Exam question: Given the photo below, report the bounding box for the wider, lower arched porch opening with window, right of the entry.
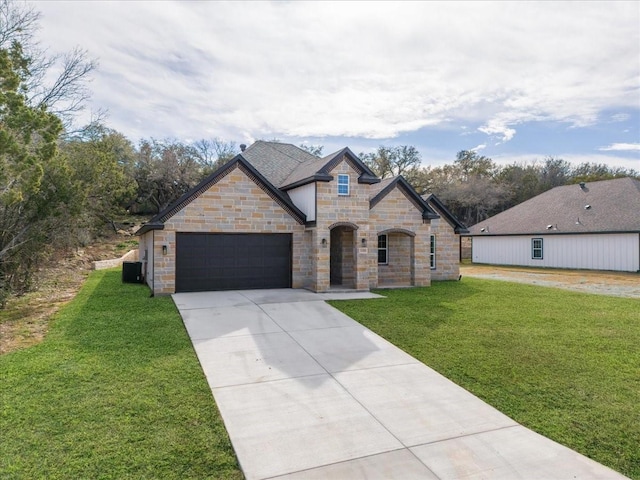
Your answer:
[378,228,416,287]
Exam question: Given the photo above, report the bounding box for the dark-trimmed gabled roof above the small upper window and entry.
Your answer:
[280,148,380,190]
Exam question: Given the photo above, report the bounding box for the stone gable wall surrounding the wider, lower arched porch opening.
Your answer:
[369,187,431,288]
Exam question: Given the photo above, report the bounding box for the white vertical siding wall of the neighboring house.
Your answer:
[472,233,640,272]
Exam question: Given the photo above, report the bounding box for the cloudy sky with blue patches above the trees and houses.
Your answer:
[30,0,640,171]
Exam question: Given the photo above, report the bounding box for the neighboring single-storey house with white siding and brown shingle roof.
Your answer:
[469,178,640,272]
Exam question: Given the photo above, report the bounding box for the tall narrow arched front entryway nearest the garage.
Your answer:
[329,223,358,288]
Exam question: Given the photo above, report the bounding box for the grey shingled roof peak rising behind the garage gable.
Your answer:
[242,140,319,187]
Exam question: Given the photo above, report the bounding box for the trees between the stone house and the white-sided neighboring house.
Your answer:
[360,146,640,226]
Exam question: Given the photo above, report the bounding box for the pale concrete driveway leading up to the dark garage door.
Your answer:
[173,289,625,480]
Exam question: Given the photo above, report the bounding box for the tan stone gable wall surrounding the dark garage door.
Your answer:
[153,164,311,294]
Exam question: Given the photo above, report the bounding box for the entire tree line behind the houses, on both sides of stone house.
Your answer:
[0,0,638,307]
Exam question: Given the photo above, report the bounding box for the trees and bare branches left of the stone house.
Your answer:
[0,0,242,307]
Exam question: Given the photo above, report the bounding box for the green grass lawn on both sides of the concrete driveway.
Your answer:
[0,271,640,480]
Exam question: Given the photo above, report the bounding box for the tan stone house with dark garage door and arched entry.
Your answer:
[137,141,466,294]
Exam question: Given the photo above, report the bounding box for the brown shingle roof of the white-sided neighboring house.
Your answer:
[469,177,640,236]
